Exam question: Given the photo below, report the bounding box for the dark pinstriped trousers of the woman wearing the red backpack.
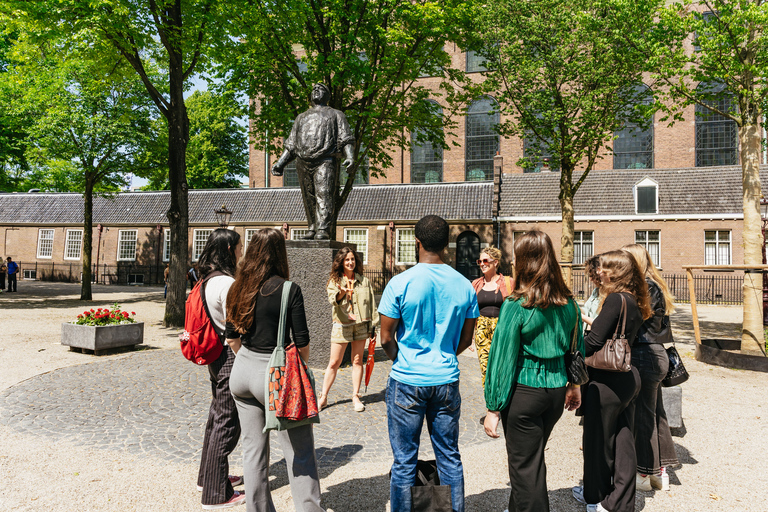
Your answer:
[197,347,240,505]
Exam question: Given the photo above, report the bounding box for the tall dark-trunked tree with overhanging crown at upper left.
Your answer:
[0,0,232,327]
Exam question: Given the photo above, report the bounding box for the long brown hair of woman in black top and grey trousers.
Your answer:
[227,228,289,334]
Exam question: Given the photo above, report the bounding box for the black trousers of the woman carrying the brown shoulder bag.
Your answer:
[581,366,640,512]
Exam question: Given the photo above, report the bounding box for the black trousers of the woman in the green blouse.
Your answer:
[501,384,565,512]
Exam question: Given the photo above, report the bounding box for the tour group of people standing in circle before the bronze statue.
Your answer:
[190,215,677,512]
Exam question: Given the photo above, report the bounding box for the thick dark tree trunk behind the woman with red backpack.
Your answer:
[164,56,189,327]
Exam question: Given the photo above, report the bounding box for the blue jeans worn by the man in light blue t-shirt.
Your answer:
[387,378,464,512]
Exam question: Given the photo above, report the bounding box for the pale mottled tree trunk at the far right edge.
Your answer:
[739,122,765,355]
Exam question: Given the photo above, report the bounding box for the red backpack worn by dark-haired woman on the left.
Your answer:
[179,272,225,365]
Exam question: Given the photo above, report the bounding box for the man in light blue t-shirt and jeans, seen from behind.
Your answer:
[379,215,479,512]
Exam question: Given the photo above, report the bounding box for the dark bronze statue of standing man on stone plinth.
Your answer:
[272,84,355,240]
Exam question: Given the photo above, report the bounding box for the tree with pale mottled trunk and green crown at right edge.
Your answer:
[640,0,768,354]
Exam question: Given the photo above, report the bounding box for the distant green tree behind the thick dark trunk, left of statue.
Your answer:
[136,91,248,190]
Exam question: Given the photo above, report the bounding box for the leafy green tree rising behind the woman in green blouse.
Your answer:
[477,0,650,278]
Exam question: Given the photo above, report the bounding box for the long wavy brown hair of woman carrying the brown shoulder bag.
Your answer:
[600,251,653,320]
